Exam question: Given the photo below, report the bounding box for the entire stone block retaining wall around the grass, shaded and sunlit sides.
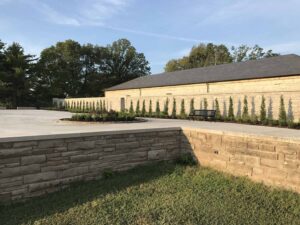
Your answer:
[0,128,300,202]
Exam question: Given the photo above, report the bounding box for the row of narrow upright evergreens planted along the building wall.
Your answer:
[128,96,300,129]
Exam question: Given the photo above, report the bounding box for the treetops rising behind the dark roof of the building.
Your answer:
[165,43,279,72]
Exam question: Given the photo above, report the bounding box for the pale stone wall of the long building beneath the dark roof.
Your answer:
[105,76,300,121]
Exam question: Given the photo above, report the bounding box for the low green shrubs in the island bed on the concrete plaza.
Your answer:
[71,111,136,122]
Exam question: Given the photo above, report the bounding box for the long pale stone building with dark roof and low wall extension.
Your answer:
[66,54,300,120]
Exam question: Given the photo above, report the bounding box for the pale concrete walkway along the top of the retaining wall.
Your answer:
[0,110,300,140]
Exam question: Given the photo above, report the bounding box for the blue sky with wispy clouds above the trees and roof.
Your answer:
[0,0,300,73]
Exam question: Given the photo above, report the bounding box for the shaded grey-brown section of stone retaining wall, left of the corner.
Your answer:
[0,129,181,202]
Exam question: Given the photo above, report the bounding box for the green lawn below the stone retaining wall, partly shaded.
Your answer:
[0,163,300,225]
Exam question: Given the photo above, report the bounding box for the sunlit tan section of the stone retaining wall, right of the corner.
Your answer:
[181,129,300,193]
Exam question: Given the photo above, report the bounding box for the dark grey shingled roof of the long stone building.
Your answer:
[106,54,300,91]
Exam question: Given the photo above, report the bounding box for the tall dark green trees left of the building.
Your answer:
[0,39,150,108]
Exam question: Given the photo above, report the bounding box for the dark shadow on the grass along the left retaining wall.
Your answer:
[0,162,176,225]
